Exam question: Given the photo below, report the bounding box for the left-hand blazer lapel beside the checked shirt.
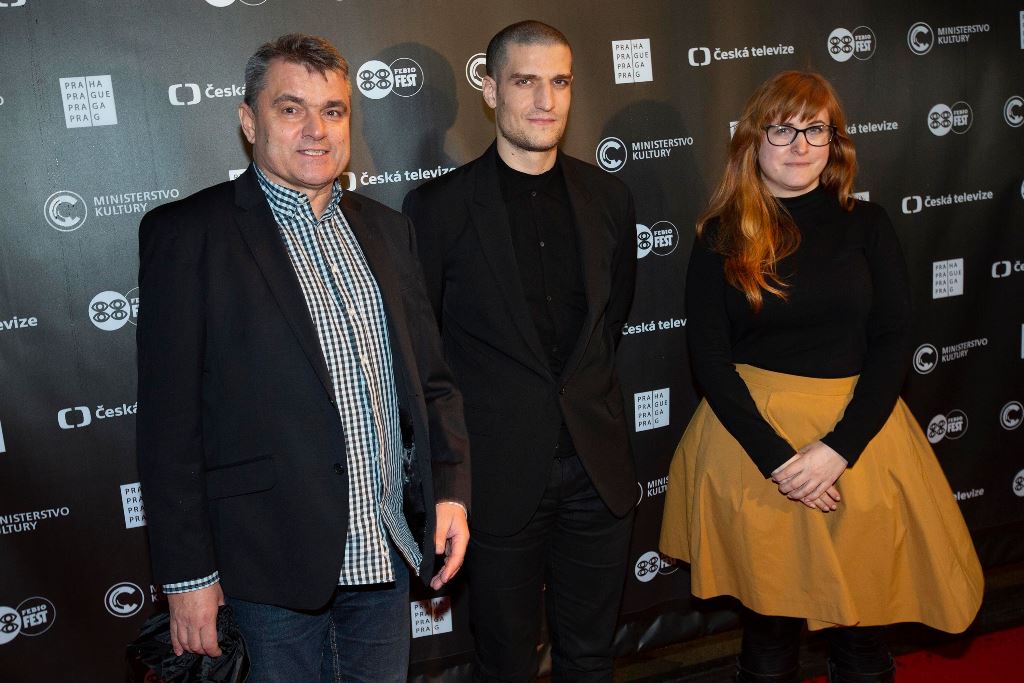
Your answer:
[234,165,334,398]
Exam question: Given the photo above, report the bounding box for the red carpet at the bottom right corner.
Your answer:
[808,627,1024,683]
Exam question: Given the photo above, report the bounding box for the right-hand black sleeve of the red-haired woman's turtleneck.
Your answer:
[821,206,910,467]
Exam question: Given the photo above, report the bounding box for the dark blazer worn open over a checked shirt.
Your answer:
[137,168,469,608]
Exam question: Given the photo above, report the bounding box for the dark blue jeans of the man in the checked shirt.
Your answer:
[227,549,412,683]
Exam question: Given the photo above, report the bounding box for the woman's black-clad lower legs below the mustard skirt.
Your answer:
[739,609,892,676]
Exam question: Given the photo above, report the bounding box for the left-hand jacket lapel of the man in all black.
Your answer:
[470,144,551,375]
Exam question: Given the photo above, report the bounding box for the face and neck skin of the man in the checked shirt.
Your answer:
[239,59,351,217]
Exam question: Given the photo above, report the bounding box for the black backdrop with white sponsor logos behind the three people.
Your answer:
[0,0,1024,681]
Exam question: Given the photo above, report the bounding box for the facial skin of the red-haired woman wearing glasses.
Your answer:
[758,109,830,197]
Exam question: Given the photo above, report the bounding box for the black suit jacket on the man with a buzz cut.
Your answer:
[403,144,637,535]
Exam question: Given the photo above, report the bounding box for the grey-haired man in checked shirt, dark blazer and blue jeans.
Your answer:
[138,35,469,683]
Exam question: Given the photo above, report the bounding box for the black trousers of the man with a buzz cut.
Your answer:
[466,450,633,681]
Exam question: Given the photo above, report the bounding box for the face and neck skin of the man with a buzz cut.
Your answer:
[483,43,572,175]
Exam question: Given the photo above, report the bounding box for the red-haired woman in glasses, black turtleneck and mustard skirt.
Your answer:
[660,72,983,683]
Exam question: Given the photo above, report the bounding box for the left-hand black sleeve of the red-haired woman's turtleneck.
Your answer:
[686,229,797,478]
